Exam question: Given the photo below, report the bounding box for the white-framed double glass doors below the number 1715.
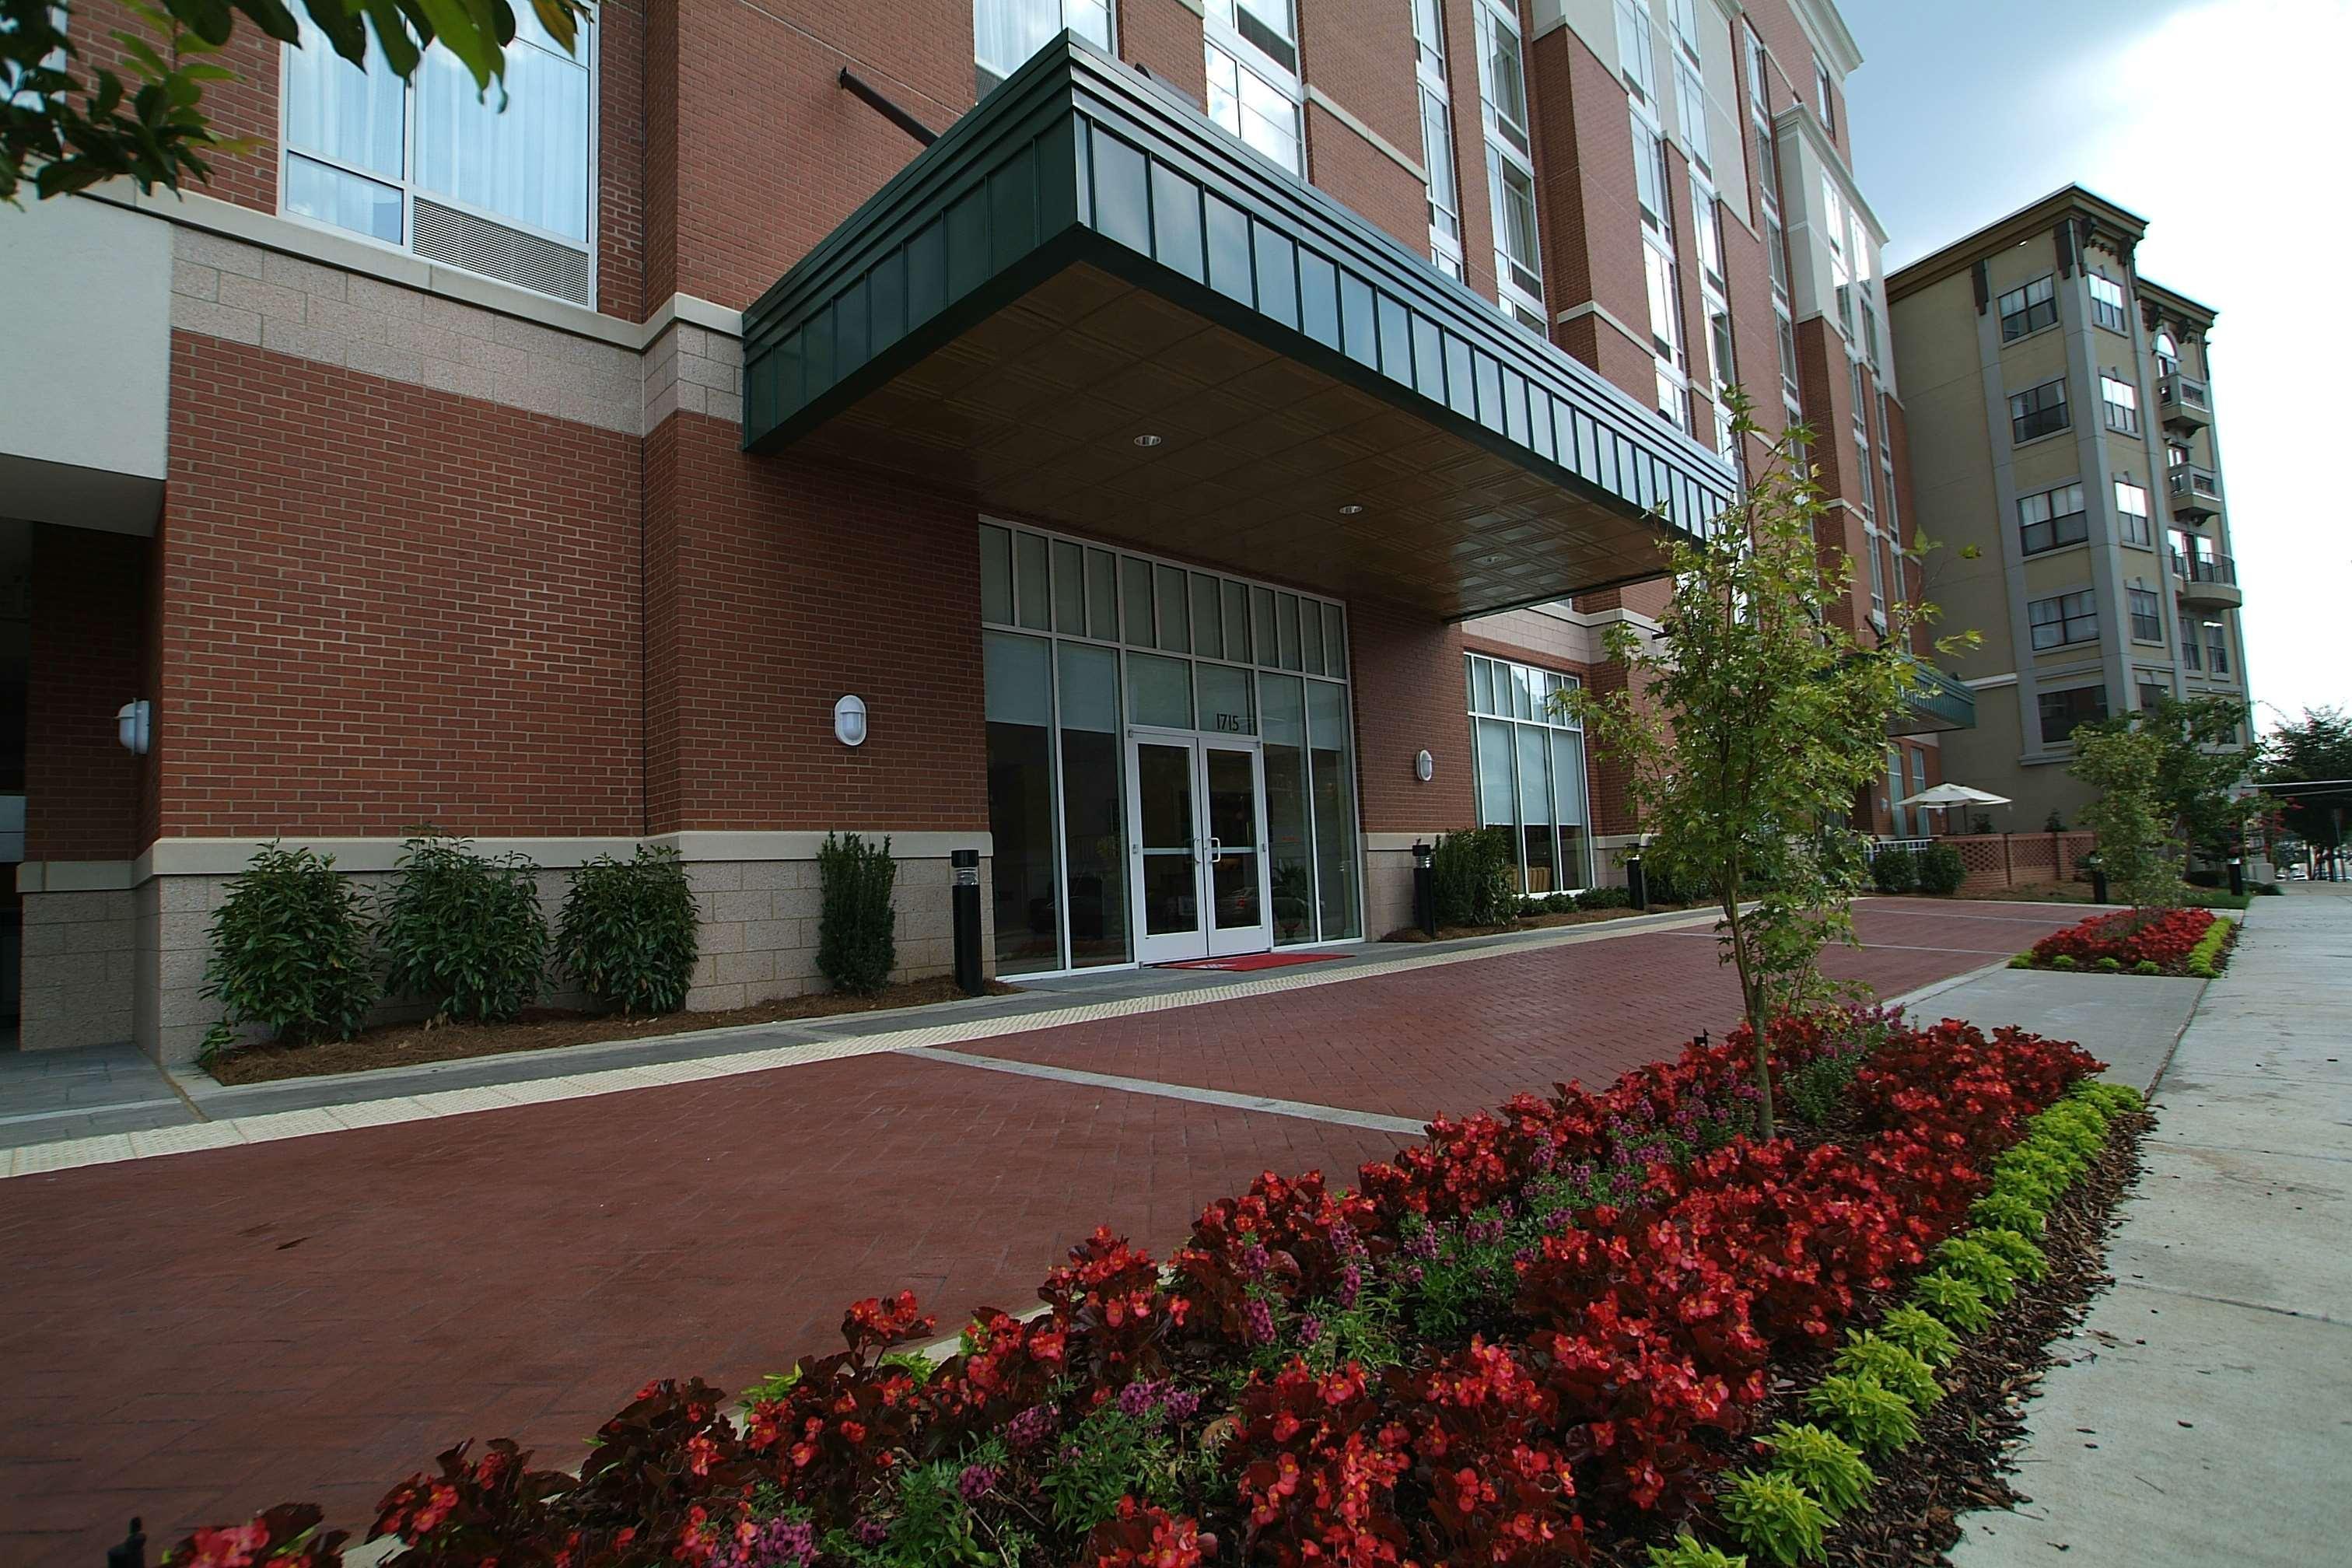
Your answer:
[1126,733,1275,964]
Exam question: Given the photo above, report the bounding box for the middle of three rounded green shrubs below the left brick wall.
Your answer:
[376,828,548,1023]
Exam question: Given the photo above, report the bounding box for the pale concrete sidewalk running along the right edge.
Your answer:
[1929,884,2352,1568]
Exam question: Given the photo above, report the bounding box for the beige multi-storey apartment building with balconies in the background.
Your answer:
[1886,186,2246,830]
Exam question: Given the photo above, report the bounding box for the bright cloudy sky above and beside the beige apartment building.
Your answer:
[1842,0,2352,729]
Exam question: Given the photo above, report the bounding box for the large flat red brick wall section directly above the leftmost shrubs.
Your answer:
[156,331,642,837]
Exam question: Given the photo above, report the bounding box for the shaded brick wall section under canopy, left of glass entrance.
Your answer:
[647,414,988,832]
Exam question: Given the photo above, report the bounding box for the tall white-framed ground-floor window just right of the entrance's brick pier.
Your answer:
[1465,653,1592,896]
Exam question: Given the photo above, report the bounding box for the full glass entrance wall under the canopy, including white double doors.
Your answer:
[981,522,1364,975]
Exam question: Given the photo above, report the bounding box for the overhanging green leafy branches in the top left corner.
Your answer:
[0,0,593,205]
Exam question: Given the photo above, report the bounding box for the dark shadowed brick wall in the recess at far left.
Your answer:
[23,524,153,860]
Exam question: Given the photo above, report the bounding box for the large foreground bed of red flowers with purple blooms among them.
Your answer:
[174,1013,2098,1568]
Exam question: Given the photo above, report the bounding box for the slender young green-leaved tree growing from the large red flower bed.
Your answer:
[1559,393,1966,1138]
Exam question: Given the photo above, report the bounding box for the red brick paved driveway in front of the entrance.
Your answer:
[0,901,2060,1566]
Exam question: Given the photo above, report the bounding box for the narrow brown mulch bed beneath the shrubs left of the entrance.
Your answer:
[207,975,1018,1083]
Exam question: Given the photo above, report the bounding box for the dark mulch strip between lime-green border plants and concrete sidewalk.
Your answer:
[1757,1115,2154,1568]
